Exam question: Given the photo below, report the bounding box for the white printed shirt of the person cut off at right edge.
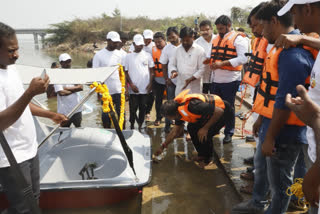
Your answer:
[307,53,320,162]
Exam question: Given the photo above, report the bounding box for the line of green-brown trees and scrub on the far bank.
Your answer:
[46,7,250,45]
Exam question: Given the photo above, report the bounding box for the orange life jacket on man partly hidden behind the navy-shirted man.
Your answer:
[243,37,268,87]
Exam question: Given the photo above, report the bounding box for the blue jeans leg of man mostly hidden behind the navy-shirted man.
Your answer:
[252,135,269,208]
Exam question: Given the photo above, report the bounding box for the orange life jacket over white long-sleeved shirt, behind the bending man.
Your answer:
[211,31,242,71]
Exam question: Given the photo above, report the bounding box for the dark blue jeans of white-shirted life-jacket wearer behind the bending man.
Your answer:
[211,81,240,136]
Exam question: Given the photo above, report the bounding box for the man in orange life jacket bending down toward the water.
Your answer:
[155,89,234,167]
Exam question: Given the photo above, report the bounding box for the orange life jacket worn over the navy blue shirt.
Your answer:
[252,47,316,126]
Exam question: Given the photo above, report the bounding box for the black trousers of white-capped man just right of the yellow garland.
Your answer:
[129,94,149,126]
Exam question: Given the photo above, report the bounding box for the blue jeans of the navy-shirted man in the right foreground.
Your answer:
[266,141,303,214]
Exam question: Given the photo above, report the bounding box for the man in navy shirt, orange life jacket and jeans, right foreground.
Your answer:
[248,0,314,214]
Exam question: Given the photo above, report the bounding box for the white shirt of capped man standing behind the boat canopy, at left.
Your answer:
[54,85,82,115]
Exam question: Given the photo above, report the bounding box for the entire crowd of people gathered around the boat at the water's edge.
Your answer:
[0,0,320,214]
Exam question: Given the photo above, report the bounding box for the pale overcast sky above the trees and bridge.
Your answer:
[0,0,261,28]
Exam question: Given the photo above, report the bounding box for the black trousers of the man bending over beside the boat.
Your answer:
[188,101,234,162]
